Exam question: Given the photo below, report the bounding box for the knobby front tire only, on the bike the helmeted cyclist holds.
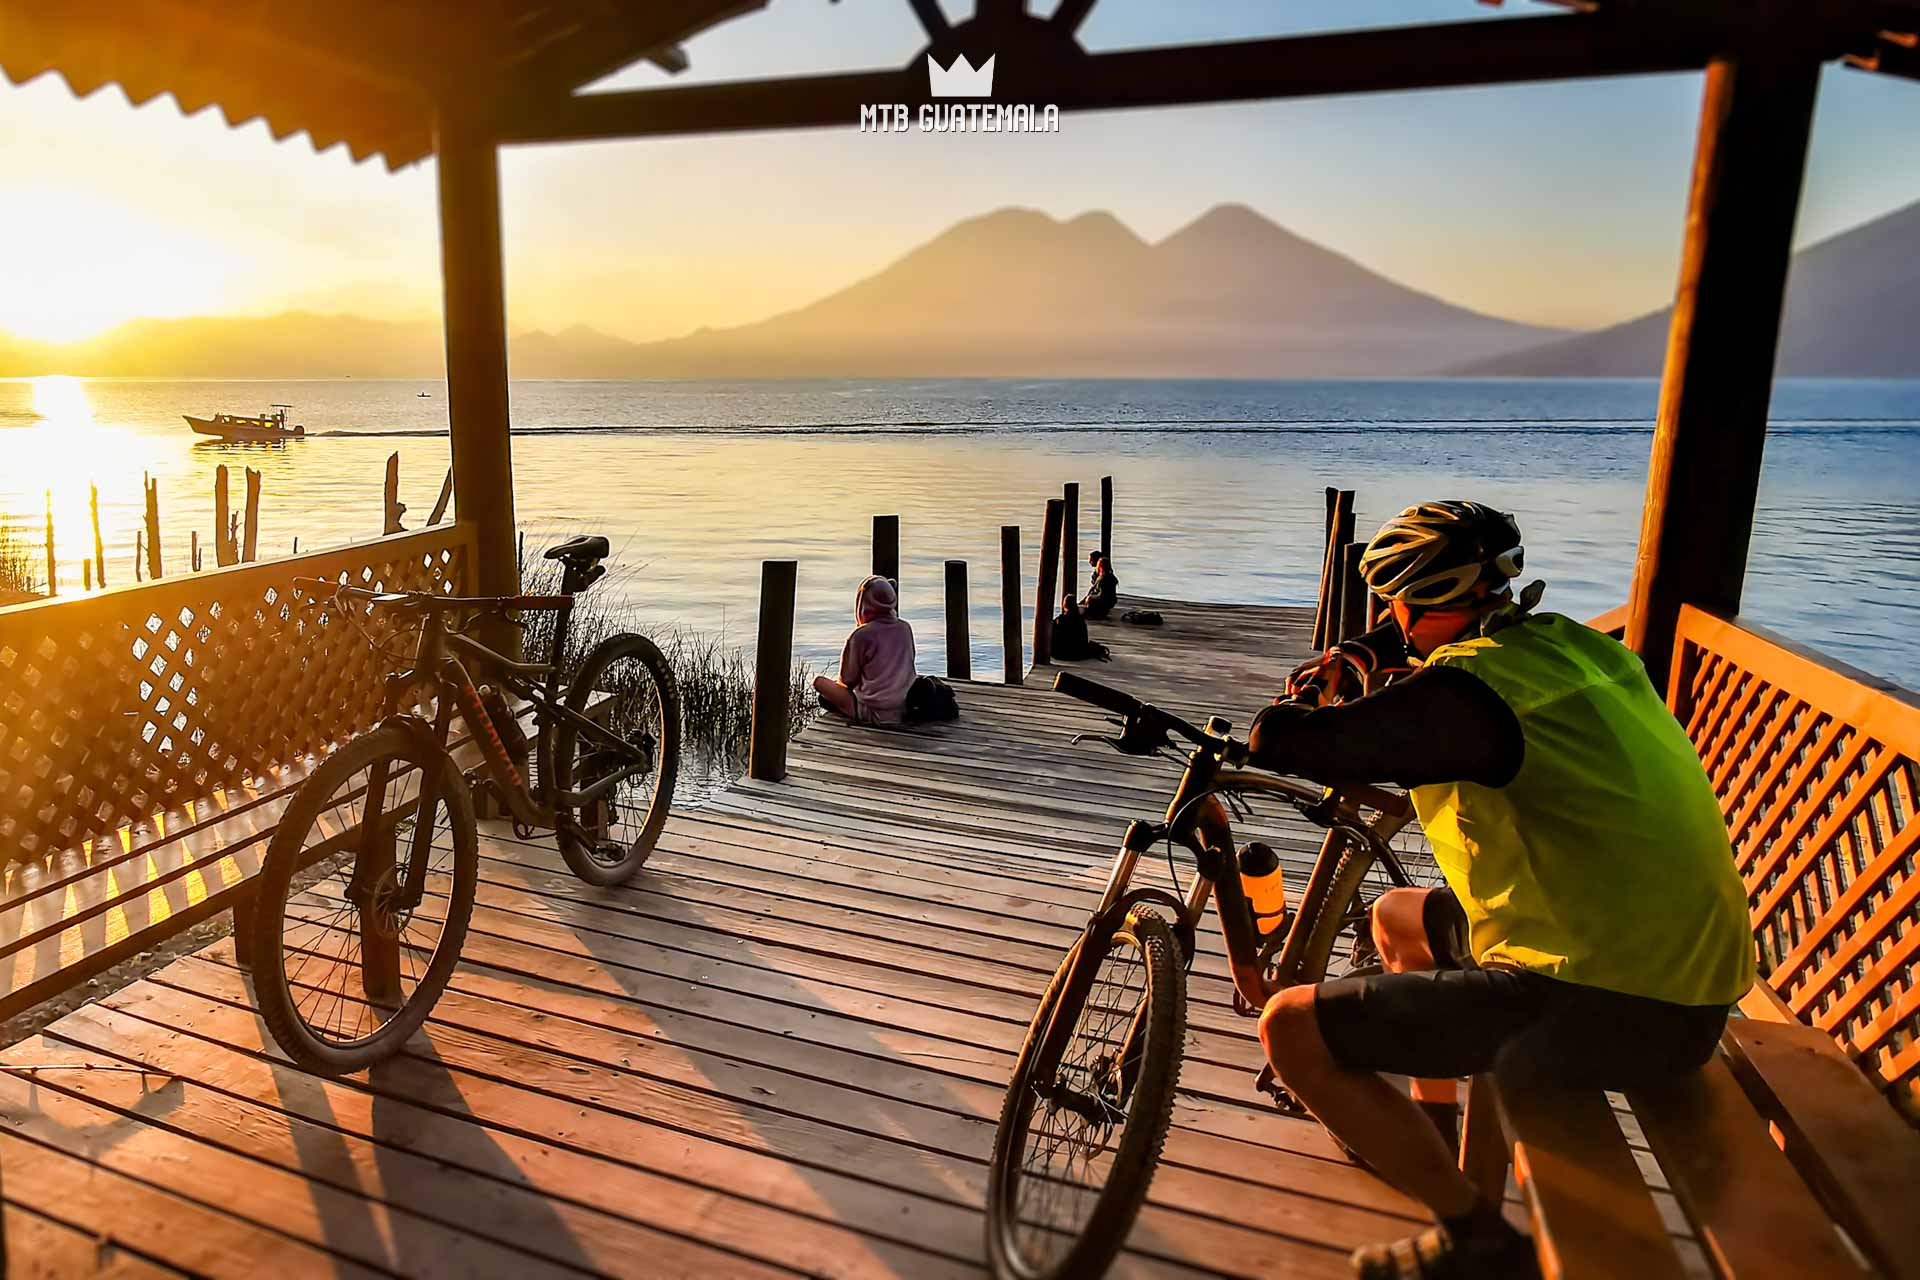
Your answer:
[987,912,1187,1280]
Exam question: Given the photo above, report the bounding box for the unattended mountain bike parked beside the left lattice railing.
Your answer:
[248,537,680,1075]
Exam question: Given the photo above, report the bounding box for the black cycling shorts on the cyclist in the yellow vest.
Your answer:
[1313,889,1726,1088]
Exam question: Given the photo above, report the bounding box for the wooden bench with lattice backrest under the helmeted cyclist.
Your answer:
[1461,608,1920,1280]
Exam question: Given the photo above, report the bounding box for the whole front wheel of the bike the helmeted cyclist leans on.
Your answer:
[987,912,1187,1280]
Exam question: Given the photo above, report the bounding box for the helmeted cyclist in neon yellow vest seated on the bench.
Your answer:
[1250,503,1755,1280]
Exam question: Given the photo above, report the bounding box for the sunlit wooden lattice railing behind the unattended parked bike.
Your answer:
[0,524,472,860]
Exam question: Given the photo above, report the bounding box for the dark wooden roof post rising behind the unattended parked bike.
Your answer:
[434,106,520,644]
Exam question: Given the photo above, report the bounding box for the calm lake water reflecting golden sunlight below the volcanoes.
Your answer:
[0,378,1920,687]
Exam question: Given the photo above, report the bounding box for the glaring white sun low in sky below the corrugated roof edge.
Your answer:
[0,184,232,342]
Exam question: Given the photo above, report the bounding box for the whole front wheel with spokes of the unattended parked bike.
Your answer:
[252,725,480,1075]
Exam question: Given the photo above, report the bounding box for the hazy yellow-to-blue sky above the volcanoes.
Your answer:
[0,0,1920,338]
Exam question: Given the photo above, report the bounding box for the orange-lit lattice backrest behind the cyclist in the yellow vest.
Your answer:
[1668,608,1920,1111]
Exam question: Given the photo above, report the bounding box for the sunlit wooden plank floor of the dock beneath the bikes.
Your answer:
[0,601,1443,1278]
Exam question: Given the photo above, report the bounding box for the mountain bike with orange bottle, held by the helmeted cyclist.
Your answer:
[987,674,1415,1280]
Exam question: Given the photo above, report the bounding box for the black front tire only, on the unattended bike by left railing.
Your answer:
[250,725,480,1077]
